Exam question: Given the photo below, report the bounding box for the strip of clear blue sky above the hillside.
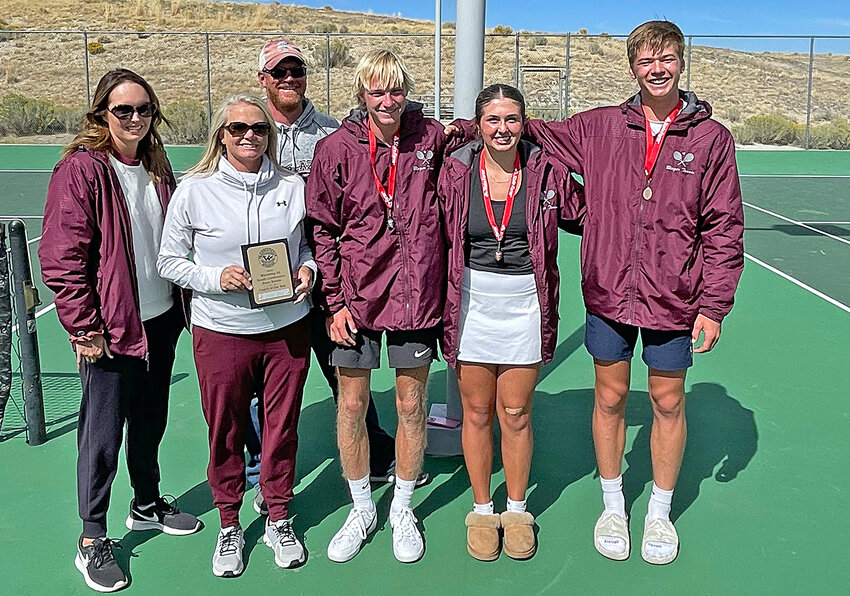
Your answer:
[260,0,850,35]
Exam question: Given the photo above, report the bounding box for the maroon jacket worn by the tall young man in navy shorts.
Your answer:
[526,92,744,330]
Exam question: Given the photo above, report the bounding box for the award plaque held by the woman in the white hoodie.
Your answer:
[242,238,296,308]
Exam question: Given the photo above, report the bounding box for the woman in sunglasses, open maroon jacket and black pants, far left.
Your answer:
[38,69,201,592]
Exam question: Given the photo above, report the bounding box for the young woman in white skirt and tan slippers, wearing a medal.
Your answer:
[438,85,581,561]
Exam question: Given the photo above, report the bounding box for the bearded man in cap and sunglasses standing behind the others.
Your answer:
[246,39,412,514]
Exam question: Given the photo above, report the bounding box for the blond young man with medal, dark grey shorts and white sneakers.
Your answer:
[307,50,460,563]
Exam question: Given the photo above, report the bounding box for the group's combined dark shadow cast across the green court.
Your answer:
[151,340,758,560]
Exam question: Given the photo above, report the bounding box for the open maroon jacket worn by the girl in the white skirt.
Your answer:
[438,140,584,366]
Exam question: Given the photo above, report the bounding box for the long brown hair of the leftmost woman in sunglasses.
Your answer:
[62,68,171,181]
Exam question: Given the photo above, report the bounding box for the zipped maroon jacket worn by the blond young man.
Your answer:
[306,103,460,330]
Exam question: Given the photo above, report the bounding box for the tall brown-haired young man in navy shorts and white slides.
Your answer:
[526,21,743,564]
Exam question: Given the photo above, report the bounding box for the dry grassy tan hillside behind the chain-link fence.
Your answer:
[0,0,850,146]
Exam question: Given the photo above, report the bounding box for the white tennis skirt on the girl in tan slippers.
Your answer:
[457,267,542,364]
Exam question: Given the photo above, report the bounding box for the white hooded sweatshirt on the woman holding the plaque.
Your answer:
[157,156,316,335]
